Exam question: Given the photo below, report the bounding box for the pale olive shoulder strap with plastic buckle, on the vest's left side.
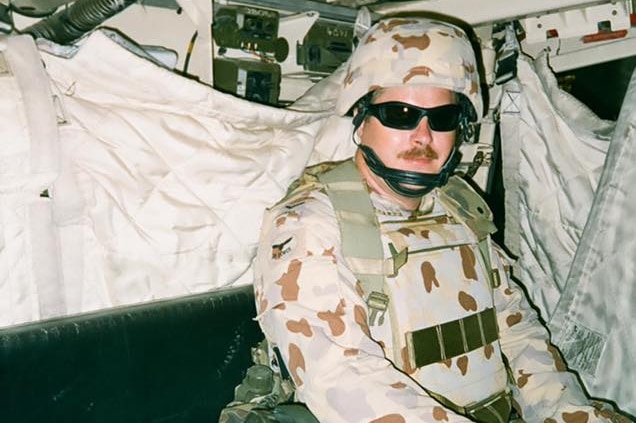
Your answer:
[318,160,395,326]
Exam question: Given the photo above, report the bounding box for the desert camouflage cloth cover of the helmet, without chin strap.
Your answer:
[336,17,483,117]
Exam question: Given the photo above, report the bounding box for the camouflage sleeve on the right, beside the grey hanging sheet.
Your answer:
[493,248,629,423]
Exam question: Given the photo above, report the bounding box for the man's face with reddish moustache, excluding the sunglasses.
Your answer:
[358,86,456,173]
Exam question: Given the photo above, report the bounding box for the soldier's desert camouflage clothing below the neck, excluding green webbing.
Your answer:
[255,161,628,423]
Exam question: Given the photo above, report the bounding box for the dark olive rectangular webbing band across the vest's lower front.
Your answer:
[406,308,499,368]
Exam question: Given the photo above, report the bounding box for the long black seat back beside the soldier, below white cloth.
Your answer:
[0,286,262,423]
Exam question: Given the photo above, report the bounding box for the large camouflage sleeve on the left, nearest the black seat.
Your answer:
[254,192,468,423]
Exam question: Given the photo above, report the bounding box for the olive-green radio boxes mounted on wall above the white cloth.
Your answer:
[212,0,356,106]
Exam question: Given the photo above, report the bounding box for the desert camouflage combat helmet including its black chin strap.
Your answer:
[335,16,483,197]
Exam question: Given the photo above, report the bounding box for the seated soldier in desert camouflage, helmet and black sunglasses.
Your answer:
[254,16,627,423]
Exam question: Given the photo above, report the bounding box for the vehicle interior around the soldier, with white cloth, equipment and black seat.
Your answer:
[0,0,636,423]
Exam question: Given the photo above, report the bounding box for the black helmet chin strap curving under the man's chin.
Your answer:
[358,144,462,198]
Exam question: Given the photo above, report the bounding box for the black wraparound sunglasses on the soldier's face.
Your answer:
[367,101,462,132]
